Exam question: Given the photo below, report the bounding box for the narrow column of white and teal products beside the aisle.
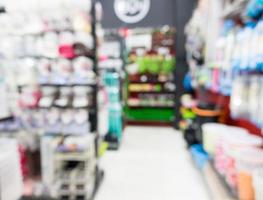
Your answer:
[99,31,125,149]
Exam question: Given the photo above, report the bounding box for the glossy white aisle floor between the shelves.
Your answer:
[95,127,209,200]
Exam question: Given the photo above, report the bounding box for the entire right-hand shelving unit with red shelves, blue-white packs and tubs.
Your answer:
[185,0,263,200]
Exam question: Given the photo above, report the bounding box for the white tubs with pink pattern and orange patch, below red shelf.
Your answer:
[202,123,263,199]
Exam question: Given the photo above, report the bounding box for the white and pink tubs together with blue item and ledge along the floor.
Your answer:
[190,123,263,200]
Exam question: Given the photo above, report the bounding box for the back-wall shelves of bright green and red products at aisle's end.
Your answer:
[125,27,176,122]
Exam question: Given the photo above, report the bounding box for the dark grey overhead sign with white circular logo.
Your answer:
[100,0,176,28]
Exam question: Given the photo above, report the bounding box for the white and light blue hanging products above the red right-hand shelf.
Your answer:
[186,1,262,96]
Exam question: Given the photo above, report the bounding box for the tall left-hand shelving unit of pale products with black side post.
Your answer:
[1,0,104,200]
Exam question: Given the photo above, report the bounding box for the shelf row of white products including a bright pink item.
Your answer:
[0,30,94,59]
